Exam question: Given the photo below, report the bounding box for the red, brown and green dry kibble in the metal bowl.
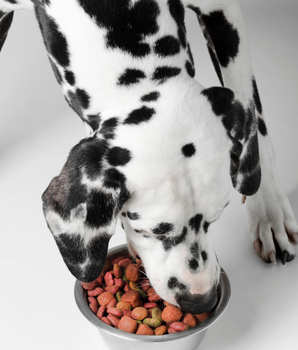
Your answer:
[82,255,212,335]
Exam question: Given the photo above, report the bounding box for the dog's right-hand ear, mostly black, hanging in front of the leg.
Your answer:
[202,87,261,196]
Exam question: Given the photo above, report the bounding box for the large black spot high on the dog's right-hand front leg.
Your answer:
[201,11,240,68]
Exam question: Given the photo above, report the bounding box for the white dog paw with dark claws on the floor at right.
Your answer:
[242,186,298,265]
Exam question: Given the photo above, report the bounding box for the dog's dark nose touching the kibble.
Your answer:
[175,288,218,314]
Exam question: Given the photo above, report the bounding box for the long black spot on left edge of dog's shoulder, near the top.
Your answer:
[35,3,69,68]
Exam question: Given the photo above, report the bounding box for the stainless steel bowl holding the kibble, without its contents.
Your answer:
[74,244,231,350]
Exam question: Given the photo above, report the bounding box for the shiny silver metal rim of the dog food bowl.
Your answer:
[74,244,231,343]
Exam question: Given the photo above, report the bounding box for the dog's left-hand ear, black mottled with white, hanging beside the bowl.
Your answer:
[42,136,129,282]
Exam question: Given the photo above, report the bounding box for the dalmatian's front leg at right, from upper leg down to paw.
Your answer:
[185,0,298,264]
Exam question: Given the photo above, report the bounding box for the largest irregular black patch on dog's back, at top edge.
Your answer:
[78,0,159,57]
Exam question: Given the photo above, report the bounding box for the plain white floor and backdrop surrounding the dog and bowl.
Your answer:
[0,0,298,350]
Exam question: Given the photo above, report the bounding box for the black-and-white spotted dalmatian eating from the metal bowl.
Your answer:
[0,0,298,313]
